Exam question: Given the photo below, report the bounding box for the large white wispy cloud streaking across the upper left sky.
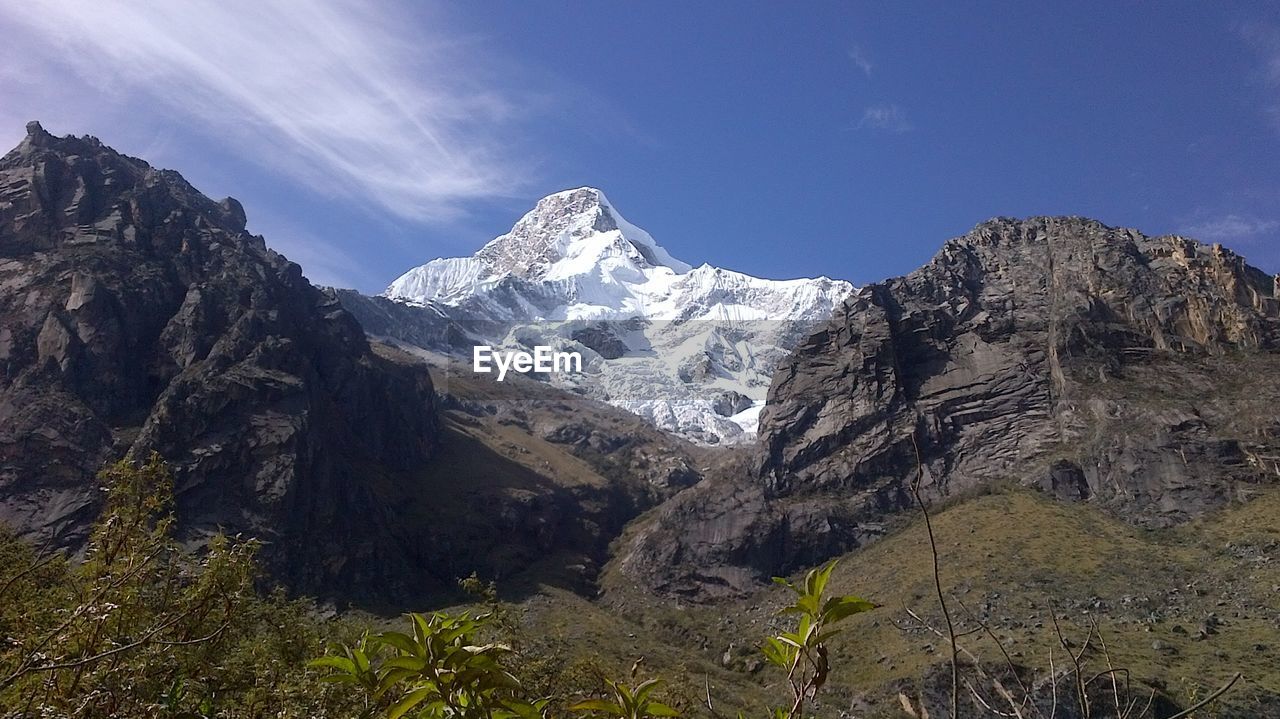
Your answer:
[0,0,529,221]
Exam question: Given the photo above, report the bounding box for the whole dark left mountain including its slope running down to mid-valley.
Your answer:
[0,124,732,598]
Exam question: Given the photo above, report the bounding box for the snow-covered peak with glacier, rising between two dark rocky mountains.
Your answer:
[384,187,854,444]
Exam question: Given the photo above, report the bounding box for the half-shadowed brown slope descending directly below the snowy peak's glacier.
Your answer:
[380,349,716,596]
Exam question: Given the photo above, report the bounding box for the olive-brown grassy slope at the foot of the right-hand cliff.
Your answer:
[509,489,1280,715]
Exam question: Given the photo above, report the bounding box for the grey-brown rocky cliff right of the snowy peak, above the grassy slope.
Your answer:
[606,217,1280,596]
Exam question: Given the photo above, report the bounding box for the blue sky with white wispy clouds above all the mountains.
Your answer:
[0,0,1280,292]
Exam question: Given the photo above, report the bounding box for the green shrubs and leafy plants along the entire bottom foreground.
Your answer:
[0,457,1267,719]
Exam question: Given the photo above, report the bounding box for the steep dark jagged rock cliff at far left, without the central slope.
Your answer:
[0,124,436,594]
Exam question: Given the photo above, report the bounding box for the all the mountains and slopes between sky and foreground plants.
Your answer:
[0,123,1280,718]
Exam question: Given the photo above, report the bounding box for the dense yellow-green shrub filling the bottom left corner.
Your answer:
[0,455,351,718]
